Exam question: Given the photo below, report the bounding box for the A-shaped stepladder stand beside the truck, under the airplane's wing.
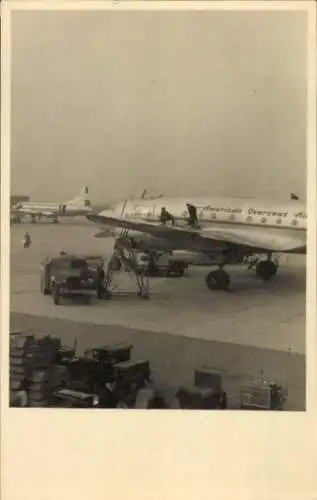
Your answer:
[104,228,149,299]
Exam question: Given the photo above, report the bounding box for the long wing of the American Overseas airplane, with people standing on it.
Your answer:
[86,214,306,252]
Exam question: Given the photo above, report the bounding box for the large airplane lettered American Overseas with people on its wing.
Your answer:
[86,193,307,290]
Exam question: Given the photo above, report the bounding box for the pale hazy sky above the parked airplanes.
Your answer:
[12,11,306,201]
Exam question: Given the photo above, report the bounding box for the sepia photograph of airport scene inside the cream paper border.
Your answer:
[9,2,308,412]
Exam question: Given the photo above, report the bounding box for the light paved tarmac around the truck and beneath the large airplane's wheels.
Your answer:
[10,221,306,410]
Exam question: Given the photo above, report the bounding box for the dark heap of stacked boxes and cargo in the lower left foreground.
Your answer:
[10,332,155,408]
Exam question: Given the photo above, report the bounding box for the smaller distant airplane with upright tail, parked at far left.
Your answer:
[11,186,92,223]
